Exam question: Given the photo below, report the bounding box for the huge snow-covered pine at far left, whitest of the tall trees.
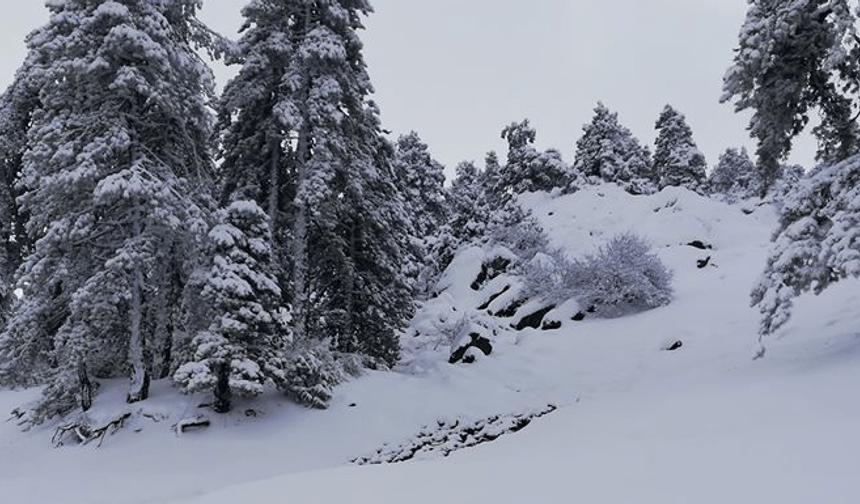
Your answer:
[0,0,217,422]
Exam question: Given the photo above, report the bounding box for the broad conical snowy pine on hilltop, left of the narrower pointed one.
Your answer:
[573,102,656,194]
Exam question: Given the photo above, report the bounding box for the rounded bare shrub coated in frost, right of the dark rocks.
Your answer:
[566,233,672,317]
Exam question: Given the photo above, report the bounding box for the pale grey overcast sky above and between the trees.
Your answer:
[0,0,814,178]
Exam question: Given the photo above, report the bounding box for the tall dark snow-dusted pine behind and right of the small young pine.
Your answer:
[221,0,412,364]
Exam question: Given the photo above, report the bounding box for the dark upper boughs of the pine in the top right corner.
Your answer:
[721,0,860,196]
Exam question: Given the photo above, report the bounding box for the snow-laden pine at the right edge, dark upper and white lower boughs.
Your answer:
[723,0,860,338]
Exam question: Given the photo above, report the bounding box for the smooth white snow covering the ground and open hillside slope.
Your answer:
[0,185,860,504]
